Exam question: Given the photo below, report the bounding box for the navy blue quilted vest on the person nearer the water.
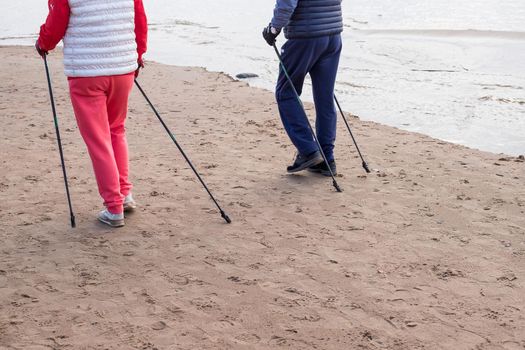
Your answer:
[284,0,343,39]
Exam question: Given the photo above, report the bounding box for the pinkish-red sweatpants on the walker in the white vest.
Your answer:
[68,73,134,214]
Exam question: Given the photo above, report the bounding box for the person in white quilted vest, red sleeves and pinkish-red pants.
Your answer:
[35,0,148,227]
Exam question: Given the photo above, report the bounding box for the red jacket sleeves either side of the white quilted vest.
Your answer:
[38,0,148,62]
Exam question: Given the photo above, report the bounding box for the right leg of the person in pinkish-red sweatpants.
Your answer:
[107,74,134,196]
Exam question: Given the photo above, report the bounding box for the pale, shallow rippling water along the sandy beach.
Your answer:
[0,0,525,155]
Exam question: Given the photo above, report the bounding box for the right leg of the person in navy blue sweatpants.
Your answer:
[310,35,342,161]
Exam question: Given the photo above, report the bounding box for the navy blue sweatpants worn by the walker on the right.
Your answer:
[275,34,342,161]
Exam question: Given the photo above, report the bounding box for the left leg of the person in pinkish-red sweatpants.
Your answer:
[69,77,124,214]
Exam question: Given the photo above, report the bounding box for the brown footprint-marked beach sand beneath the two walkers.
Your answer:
[0,47,525,350]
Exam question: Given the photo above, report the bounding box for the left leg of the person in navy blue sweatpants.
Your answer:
[275,39,326,156]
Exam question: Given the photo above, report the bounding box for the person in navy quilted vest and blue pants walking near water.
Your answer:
[263,0,343,176]
